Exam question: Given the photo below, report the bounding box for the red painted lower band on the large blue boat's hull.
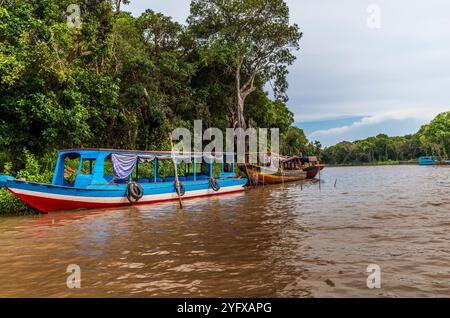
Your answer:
[7,188,245,213]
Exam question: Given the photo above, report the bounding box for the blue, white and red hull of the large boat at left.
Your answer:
[6,179,247,213]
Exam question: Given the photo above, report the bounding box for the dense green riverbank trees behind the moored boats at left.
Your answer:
[0,0,312,171]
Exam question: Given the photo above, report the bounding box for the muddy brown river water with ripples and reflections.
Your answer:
[0,166,450,297]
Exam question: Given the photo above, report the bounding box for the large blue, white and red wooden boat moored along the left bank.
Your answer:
[4,149,247,213]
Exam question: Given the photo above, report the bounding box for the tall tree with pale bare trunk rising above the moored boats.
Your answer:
[188,0,302,128]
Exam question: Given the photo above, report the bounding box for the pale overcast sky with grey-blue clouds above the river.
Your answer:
[124,0,450,145]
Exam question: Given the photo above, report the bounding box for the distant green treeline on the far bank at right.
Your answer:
[320,112,450,165]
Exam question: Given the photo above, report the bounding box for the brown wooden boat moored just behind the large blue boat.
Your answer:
[239,157,307,186]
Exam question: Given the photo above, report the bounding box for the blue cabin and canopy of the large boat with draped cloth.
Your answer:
[52,148,239,187]
